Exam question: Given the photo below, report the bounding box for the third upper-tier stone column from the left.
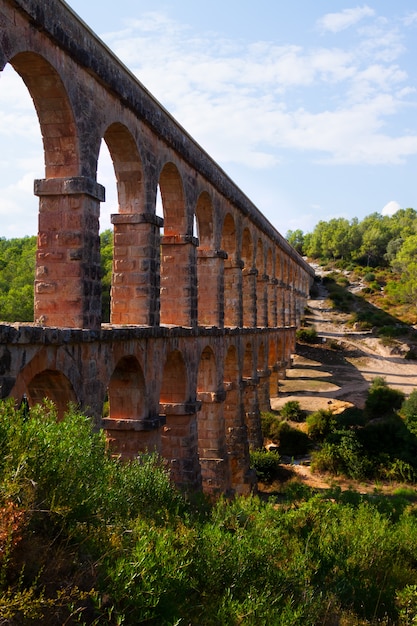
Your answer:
[161,235,198,327]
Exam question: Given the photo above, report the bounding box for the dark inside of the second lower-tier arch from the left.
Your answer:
[107,355,146,420]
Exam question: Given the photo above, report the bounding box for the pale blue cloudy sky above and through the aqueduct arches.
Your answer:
[0,0,417,237]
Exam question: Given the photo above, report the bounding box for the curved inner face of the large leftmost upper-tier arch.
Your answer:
[10,52,79,178]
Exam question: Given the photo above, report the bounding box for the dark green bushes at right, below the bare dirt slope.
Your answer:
[262,376,417,484]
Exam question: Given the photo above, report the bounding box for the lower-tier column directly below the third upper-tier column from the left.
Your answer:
[160,402,202,489]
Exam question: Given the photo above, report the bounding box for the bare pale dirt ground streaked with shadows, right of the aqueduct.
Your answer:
[266,280,417,493]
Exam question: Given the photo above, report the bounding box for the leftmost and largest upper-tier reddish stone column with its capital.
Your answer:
[34,176,104,328]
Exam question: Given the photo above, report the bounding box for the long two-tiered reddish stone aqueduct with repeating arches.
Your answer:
[0,0,313,493]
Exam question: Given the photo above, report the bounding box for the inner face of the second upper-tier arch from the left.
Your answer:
[103,122,145,214]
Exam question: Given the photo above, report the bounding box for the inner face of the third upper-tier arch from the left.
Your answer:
[159,163,188,235]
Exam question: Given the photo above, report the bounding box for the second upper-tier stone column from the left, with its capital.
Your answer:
[110,213,163,326]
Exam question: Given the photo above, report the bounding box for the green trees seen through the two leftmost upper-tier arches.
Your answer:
[0,230,113,322]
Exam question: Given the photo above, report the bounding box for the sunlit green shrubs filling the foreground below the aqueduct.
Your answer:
[0,401,417,626]
